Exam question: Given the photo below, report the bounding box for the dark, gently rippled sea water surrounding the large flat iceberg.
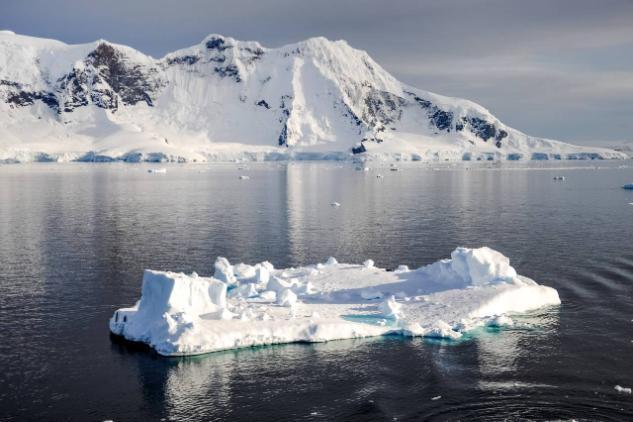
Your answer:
[0,162,633,421]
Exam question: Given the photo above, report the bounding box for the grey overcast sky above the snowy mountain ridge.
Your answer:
[0,0,633,144]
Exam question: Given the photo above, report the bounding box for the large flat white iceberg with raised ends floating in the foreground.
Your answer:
[110,247,560,356]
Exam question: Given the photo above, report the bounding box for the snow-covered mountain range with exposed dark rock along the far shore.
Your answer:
[0,31,626,162]
